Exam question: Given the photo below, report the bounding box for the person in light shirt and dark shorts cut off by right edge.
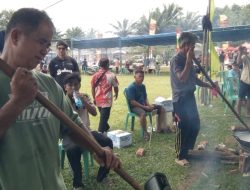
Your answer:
[237,46,250,117]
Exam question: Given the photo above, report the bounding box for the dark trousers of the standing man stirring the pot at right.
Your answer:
[173,93,200,160]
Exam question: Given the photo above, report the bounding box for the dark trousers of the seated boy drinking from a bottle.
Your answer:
[66,131,113,187]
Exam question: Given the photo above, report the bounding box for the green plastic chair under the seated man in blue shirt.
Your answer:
[123,88,153,138]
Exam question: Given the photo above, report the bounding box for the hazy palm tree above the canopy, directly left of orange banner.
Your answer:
[110,18,135,37]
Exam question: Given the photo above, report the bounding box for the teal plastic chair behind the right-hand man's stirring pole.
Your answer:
[224,77,239,114]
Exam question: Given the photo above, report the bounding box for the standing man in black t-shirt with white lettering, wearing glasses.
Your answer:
[49,40,80,88]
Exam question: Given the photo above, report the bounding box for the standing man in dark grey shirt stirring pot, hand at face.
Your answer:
[170,32,212,166]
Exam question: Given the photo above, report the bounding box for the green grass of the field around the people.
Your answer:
[63,72,250,190]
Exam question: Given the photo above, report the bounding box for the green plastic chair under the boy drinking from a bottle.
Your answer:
[58,142,94,178]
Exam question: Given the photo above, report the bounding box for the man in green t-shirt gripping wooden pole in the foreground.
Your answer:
[0,8,120,190]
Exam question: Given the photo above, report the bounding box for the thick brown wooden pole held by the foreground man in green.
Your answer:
[0,59,142,190]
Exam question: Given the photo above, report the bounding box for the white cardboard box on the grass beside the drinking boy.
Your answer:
[107,130,132,148]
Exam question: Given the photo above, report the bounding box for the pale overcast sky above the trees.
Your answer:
[0,0,250,36]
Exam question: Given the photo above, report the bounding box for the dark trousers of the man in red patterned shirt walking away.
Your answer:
[98,107,111,133]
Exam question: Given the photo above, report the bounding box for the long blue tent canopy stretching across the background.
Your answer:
[71,25,250,49]
